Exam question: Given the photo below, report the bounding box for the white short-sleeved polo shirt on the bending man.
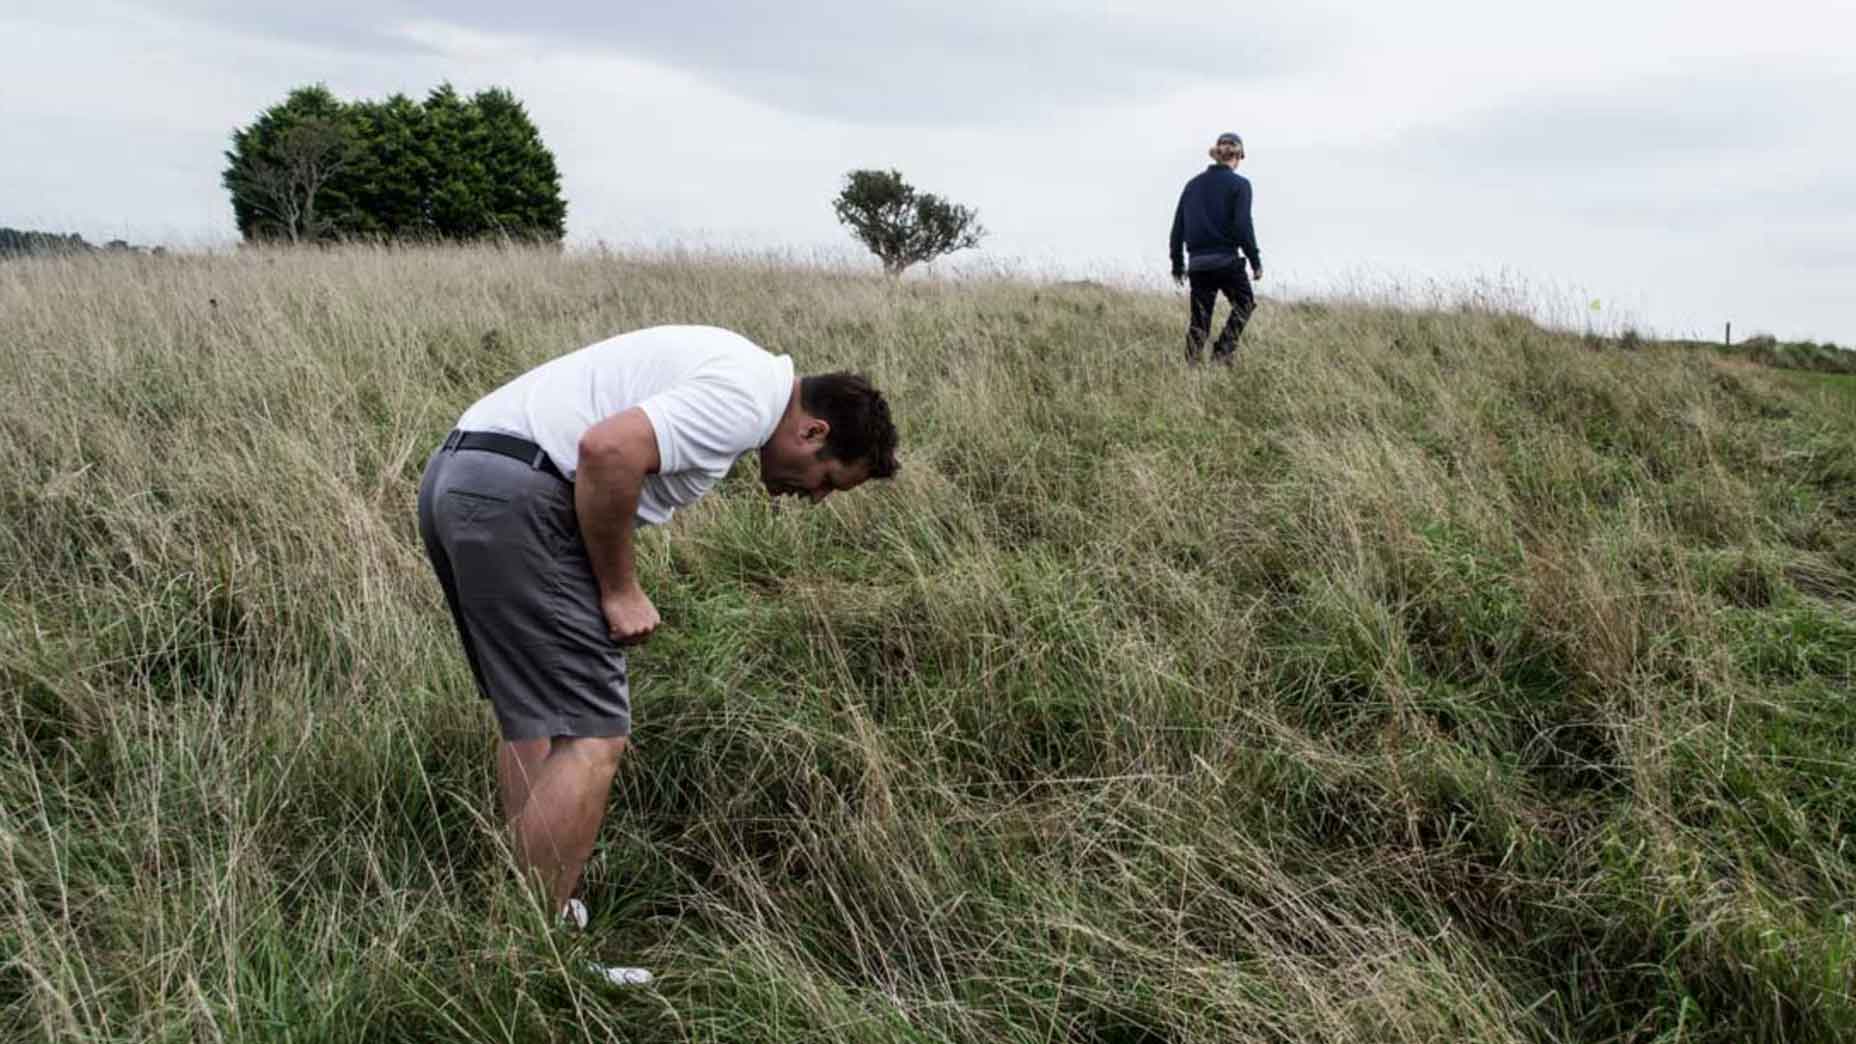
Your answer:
[458,327,793,526]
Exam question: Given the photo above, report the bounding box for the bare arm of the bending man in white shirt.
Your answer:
[574,407,661,645]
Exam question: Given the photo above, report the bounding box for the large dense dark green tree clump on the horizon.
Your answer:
[221,84,568,243]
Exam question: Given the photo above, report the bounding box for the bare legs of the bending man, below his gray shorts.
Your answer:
[497,736,629,910]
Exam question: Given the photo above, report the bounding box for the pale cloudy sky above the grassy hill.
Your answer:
[0,0,1856,346]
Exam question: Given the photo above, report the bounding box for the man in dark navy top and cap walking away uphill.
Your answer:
[1167,130,1264,362]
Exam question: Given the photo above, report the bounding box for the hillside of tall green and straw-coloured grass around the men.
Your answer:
[0,249,1856,1044]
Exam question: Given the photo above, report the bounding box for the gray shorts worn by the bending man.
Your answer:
[419,438,631,739]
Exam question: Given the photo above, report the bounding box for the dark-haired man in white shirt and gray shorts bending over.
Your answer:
[419,327,896,981]
